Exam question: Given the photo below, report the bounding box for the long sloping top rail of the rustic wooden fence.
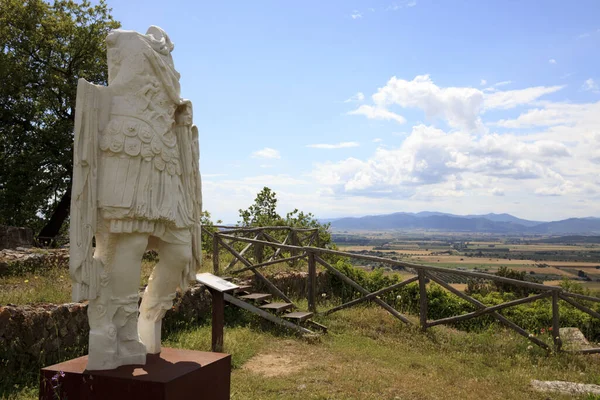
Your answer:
[221,234,562,292]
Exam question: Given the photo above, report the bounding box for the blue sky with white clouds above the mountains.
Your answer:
[107,0,600,223]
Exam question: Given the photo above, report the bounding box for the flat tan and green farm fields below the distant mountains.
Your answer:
[334,232,600,291]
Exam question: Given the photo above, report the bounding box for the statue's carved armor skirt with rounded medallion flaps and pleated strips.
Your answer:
[98,112,194,233]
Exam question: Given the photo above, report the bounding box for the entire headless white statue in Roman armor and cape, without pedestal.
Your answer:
[70,26,202,370]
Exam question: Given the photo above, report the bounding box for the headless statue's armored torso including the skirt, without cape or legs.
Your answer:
[98,31,193,232]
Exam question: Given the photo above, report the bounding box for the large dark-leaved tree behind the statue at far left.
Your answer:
[0,0,120,237]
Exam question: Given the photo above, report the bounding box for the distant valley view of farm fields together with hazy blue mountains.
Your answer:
[325,212,600,291]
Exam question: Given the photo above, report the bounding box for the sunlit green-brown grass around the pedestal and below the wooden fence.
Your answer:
[8,307,600,400]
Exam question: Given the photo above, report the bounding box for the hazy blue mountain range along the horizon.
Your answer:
[321,211,600,235]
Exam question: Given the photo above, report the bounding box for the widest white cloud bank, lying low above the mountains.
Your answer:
[313,125,571,197]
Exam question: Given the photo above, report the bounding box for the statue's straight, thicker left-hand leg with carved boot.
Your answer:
[87,232,148,370]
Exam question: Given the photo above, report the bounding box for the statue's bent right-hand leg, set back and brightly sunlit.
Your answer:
[138,240,192,354]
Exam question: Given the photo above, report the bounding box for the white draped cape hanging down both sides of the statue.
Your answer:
[70,31,202,301]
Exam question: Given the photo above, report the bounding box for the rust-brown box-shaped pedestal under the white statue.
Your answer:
[40,348,231,400]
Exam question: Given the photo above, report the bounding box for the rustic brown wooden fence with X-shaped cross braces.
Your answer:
[205,227,600,354]
